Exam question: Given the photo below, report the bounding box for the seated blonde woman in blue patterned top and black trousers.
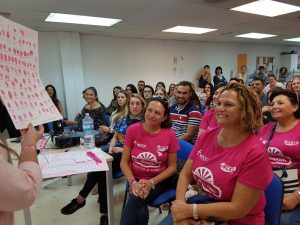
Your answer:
[61,94,146,225]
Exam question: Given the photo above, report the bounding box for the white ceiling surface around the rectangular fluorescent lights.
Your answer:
[0,0,300,45]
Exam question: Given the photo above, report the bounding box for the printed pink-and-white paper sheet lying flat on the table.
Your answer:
[38,149,108,178]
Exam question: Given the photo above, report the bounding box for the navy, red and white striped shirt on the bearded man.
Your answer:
[170,102,202,144]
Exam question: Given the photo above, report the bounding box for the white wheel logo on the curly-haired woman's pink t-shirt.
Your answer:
[193,167,222,198]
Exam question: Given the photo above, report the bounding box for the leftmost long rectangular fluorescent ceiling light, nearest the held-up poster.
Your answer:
[45,13,121,27]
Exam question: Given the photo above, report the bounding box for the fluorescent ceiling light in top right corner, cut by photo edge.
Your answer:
[230,0,300,17]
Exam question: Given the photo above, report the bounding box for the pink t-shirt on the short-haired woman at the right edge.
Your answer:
[257,120,300,171]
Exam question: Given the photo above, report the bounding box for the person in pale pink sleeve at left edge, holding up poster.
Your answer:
[0,124,44,225]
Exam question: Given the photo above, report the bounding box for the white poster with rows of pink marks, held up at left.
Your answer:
[0,16,62,129]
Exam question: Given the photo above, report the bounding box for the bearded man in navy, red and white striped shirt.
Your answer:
[170,81,202,144]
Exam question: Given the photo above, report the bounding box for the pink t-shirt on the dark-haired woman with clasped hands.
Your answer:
[125,123,179,179]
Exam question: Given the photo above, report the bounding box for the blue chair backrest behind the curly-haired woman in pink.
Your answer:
[264,174,283,225]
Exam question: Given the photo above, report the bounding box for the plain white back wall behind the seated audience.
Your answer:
[39,32,299,117]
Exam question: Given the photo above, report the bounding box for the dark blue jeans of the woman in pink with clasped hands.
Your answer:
[120,180,170,225]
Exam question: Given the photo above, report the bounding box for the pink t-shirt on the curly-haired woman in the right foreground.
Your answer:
[189,128,272,225]
